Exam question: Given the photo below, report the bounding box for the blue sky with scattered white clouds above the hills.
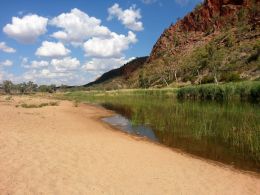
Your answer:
[0,0,201,85]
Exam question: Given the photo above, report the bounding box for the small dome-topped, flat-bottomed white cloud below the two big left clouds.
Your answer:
[35,41,70,57]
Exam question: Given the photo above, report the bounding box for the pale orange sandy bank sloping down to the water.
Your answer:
[0,97,260,195]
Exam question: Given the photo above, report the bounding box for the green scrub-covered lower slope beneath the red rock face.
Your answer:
[134,29,260,88]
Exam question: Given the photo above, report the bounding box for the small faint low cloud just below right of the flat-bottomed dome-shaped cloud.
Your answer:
[51,57,80,72]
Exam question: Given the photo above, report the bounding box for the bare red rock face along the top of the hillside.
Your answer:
[148,0,260,62]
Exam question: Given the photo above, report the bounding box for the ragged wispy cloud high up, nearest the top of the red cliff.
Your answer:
[108,3,143,31]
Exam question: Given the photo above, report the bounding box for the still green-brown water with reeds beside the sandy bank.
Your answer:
[99,96,260,172]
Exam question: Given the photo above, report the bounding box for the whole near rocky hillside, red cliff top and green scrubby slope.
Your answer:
[85,0,260,88]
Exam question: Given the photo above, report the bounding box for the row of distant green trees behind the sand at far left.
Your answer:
[0,80,57,94]
